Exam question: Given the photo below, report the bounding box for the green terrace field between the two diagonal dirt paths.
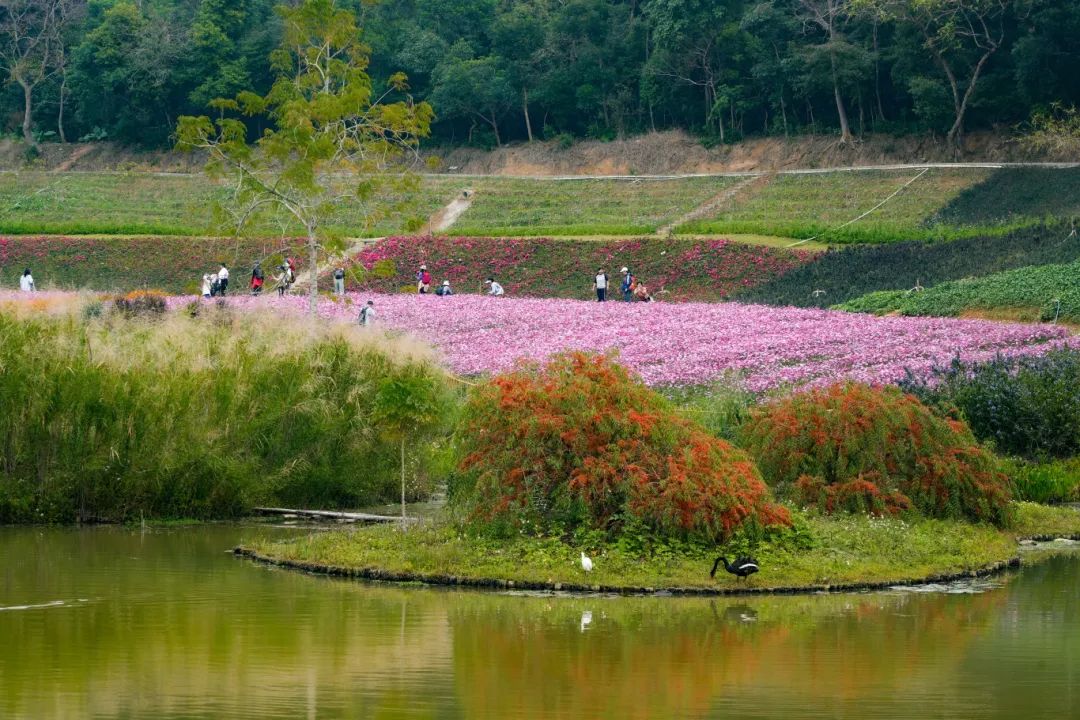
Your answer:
[453,177,741,235]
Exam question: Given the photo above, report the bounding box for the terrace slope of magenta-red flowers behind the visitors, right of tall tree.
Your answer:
[350,235,814,301]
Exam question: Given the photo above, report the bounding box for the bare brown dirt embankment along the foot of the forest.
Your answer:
[0,131,1062,176]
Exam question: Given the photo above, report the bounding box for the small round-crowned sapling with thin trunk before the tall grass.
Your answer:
[374,363,449,518]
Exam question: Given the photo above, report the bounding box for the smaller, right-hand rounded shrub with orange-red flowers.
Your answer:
[742,383,1011,525]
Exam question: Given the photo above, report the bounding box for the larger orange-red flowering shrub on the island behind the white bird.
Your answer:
[451,353,791,540]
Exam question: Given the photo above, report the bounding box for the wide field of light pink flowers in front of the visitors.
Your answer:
[171,294,1080,391]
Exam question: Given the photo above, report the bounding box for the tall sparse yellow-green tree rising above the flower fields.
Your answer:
[177,0,433,316]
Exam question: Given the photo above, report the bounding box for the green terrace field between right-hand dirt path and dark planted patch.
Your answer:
[679,167,993,242]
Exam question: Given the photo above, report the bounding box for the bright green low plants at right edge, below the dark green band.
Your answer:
[837,261,1080,323]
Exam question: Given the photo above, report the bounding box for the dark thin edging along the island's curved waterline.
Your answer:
[232,547,1021,597]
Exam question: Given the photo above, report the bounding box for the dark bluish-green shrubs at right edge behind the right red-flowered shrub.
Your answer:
[902,349,1080,459]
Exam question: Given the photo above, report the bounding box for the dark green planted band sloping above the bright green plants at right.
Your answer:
[735,221,1080,308]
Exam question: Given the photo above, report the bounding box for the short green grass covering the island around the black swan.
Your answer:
[240,503,1080,589]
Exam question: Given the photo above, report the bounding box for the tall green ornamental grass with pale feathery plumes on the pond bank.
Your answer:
[0,300,442,522]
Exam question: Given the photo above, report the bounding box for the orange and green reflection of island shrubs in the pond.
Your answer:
[449,590,1007,718]
